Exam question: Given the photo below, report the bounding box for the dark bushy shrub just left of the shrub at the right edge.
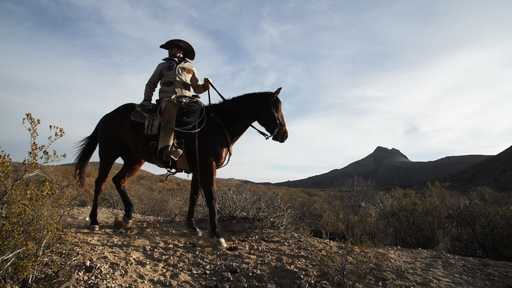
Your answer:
[379,184,450,249]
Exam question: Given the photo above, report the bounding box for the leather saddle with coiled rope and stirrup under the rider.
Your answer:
[130,95,205,175]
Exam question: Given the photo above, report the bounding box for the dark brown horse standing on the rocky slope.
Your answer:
[75,88,288,248]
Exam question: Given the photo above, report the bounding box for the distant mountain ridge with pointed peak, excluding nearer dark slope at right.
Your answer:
[274,146,490,189]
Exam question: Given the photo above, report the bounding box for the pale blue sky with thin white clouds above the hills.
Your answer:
[0,0,512,182]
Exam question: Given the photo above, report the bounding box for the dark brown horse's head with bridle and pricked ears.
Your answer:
[258,88,288,143]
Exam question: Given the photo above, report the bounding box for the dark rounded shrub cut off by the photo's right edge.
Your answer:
[449,188,512,261]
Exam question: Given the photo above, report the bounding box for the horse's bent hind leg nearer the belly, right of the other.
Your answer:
[112,158,144,227]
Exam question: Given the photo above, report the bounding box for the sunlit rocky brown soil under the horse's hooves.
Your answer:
[61,208,512,288]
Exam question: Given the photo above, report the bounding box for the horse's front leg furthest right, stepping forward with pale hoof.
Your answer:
[201,164,227,249]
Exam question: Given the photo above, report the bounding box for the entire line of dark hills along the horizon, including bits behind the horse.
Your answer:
[62,146,512,192]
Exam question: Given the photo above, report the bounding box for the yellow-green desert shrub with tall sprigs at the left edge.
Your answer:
[0,114,76,287]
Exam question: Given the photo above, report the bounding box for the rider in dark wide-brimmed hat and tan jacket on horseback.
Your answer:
[140,39,211,167]
